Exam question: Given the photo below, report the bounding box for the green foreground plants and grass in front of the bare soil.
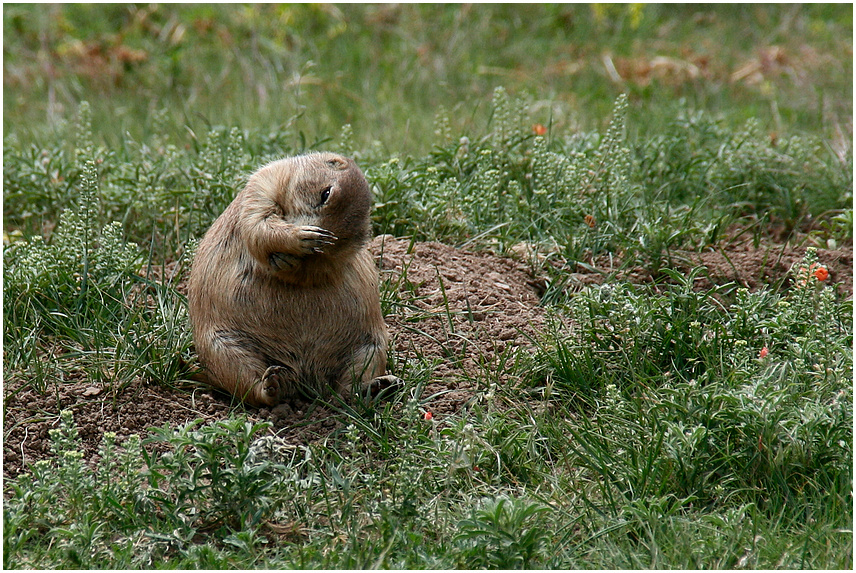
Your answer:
[4,247,853,568]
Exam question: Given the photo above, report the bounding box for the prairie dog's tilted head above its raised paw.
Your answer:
[248,152,372,247]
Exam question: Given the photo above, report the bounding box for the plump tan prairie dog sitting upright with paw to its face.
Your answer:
[188,153,388,406]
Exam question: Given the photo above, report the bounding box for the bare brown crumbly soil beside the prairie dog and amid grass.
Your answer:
[3,236,853,478]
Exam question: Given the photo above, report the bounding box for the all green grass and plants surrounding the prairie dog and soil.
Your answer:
[3,5,853,569]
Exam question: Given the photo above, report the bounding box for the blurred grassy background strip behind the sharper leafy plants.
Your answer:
[3,4,853,155]
